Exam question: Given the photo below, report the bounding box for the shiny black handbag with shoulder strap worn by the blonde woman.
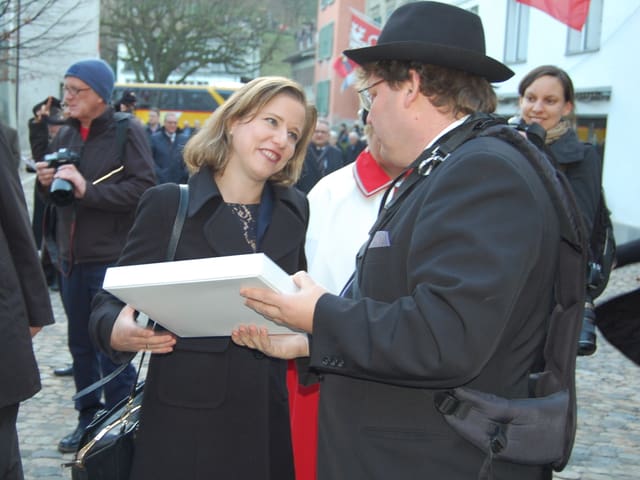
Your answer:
[65,185,188,480]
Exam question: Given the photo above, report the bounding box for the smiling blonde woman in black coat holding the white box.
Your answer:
[90,77,316,480]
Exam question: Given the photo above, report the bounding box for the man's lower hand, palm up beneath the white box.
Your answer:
[231,325,309,360]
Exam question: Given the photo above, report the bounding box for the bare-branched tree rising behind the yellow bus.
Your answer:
[101,0,315,83]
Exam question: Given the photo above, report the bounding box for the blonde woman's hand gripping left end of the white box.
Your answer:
[111,305,176,353]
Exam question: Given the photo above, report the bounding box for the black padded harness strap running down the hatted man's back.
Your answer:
[435,125,587,478]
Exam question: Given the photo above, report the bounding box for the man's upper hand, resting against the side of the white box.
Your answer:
[240,272,327,333]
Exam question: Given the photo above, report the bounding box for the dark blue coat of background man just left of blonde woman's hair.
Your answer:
[151,131,189,184]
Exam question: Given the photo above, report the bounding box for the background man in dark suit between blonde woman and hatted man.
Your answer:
[296,119,344,193]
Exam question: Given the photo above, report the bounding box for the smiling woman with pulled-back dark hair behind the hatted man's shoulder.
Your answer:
[518,65,602,355]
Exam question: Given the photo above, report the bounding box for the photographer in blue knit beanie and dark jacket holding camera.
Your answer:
[36,59,155,453]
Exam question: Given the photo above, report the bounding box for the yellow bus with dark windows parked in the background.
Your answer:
[112,82,242,128]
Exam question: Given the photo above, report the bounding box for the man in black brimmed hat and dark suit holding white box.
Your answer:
[233,2,560,480]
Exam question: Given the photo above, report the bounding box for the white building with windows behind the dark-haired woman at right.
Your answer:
[365,0,640,243]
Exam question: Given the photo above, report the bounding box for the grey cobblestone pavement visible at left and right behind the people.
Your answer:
[18,174,640,480]
